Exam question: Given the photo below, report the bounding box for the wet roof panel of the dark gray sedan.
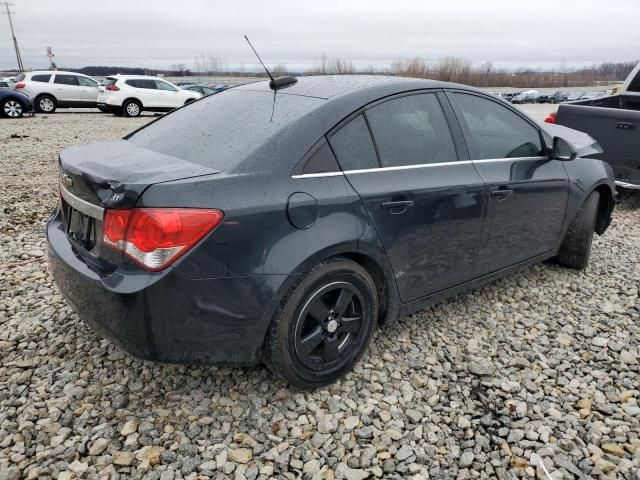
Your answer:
[236,75,457,100]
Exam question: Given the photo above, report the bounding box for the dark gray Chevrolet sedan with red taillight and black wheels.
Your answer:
[47,76,614,388]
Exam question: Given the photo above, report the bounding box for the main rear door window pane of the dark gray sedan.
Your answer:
[366,93,458,167]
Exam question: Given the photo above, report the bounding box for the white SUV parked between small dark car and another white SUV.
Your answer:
[14,70,98,113]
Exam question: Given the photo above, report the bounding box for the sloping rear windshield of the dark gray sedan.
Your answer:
[128,89,324,171]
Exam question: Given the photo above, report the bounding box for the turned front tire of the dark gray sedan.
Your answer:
[558,191,600,270]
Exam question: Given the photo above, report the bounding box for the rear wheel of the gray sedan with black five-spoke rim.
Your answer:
[264,257,378,389]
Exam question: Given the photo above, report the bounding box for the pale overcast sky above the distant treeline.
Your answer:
[0,0,640,70]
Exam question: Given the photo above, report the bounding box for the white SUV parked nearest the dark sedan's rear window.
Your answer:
[98,75,202,117]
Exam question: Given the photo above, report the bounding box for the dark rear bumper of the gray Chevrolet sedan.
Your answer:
[47,214,288,365]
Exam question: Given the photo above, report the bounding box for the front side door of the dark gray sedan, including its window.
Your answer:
[447,92,569,275]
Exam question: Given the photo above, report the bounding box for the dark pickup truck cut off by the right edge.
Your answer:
[545,65,640,190]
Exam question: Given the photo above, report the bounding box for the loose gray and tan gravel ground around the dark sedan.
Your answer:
[0,109,640,480]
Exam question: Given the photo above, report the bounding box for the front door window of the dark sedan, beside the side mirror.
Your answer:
[449,93,544,160]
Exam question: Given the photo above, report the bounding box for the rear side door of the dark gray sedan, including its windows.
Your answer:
[329,93,485,302]
